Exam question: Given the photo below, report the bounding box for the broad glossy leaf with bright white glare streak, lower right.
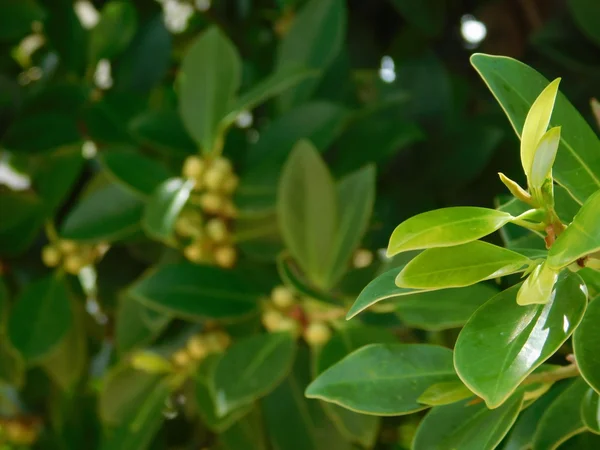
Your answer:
[454,273,586,408]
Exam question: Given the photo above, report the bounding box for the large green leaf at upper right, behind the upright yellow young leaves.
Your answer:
[471,54,600,203]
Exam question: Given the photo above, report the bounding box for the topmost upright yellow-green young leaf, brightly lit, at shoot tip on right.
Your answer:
[521,78,560,182]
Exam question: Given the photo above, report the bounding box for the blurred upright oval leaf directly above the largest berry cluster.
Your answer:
[177,26,241,153]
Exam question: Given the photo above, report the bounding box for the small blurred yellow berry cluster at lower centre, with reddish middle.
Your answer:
[262,286,331,347]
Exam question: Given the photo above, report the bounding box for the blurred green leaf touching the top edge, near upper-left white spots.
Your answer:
[89,1,137,65]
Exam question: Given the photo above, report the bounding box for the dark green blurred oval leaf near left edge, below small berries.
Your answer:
[8,275,73,363]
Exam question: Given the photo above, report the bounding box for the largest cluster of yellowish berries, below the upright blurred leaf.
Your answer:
[175,156,239,268]
